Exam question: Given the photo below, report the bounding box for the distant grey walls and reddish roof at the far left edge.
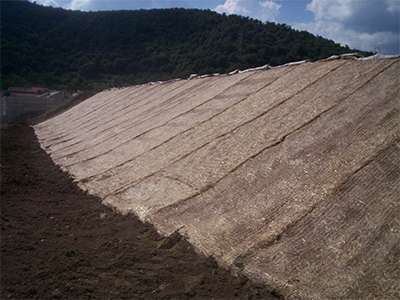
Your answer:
[0,87,69,122]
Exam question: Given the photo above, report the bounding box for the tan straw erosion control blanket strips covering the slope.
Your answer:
[34,59,400,299]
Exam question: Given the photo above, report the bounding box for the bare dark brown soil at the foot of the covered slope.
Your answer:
[1,123,279,299]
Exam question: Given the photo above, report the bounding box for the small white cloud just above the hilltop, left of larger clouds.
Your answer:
[215,0,281,22]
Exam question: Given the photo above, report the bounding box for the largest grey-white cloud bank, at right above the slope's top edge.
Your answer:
[293,0,400,54]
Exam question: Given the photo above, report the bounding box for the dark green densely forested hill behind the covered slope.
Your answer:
[1,0,368,91]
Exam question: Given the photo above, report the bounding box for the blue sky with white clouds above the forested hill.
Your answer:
[31,0,400,54]
